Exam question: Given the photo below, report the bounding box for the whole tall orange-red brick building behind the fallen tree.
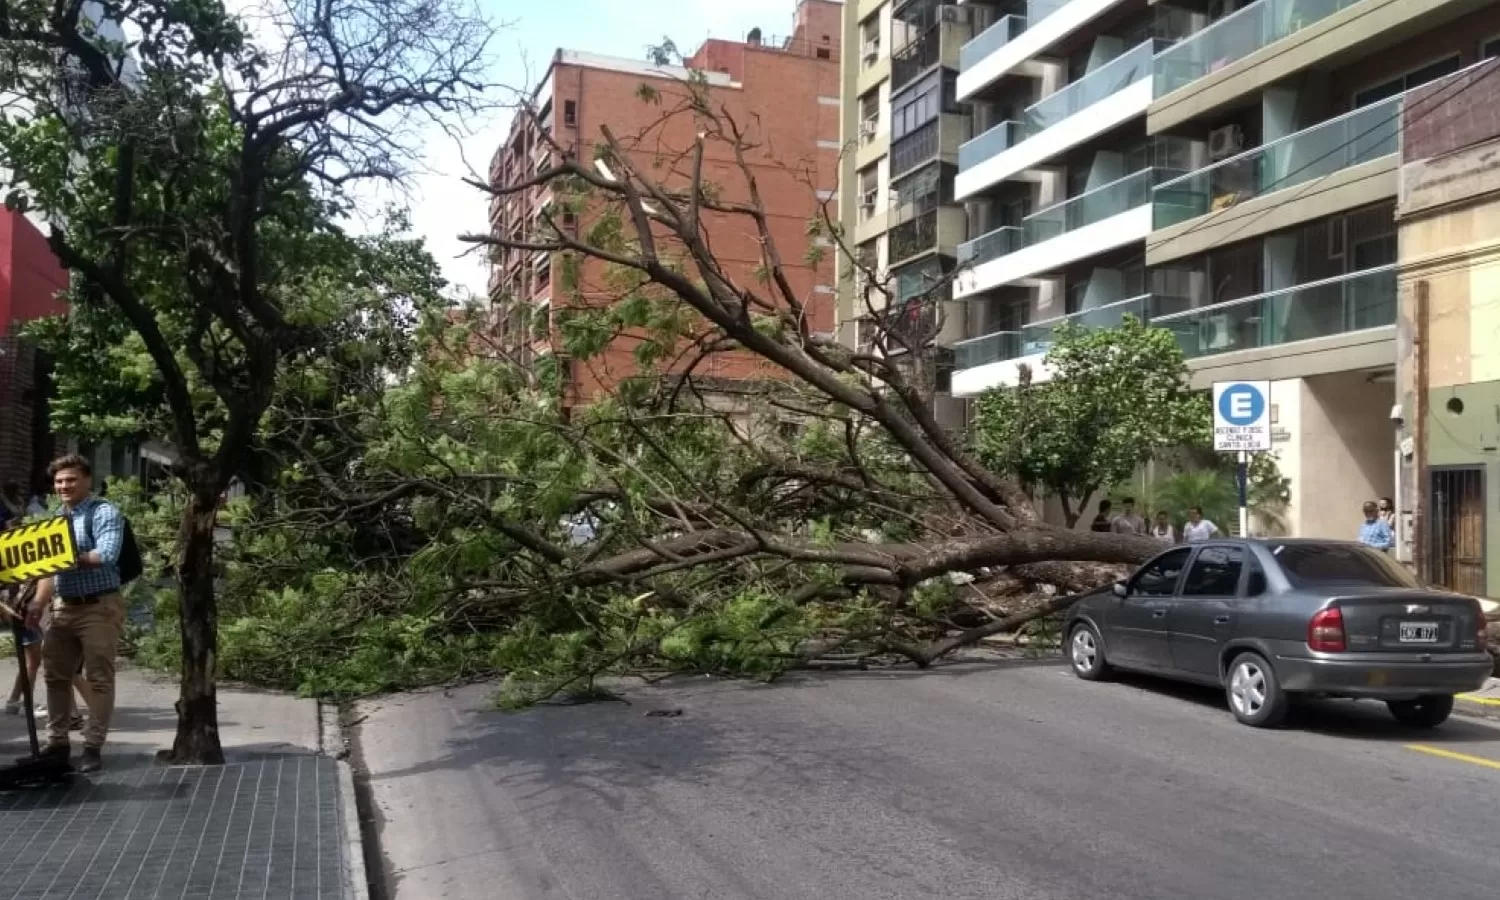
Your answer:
[489,0,843,404]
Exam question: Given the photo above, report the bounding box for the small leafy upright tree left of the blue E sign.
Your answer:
[974,317,1211,528]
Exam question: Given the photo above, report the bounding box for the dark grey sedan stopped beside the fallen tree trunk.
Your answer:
[1064,540,1494,728]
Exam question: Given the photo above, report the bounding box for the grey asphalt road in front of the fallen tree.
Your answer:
[356,663,1500,900]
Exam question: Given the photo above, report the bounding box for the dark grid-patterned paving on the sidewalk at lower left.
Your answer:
[0,755,345,900]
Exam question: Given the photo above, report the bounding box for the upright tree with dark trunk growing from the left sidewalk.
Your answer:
[0,0,491,764]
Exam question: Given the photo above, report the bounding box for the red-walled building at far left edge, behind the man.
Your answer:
[0,210,68,489]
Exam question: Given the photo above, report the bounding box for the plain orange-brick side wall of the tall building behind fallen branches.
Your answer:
[510,0,842,402]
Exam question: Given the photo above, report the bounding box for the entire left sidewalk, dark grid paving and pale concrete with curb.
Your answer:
[0,660,365,900]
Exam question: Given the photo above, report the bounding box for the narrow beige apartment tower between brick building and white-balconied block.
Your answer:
[839,0,974,425]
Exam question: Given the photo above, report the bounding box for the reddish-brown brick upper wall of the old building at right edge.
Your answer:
[1401,60,1500,162]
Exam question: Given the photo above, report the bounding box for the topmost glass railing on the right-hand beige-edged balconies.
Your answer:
[1152,0,1359,98]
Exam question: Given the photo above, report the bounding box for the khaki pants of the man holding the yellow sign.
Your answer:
[42,594,125,750]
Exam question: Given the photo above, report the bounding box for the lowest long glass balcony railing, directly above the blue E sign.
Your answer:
[1151,266,1397,359]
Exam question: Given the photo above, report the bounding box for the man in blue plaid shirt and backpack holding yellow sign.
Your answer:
[27,455,125,773]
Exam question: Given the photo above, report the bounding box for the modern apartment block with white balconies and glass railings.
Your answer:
[953,0,1500,537]
